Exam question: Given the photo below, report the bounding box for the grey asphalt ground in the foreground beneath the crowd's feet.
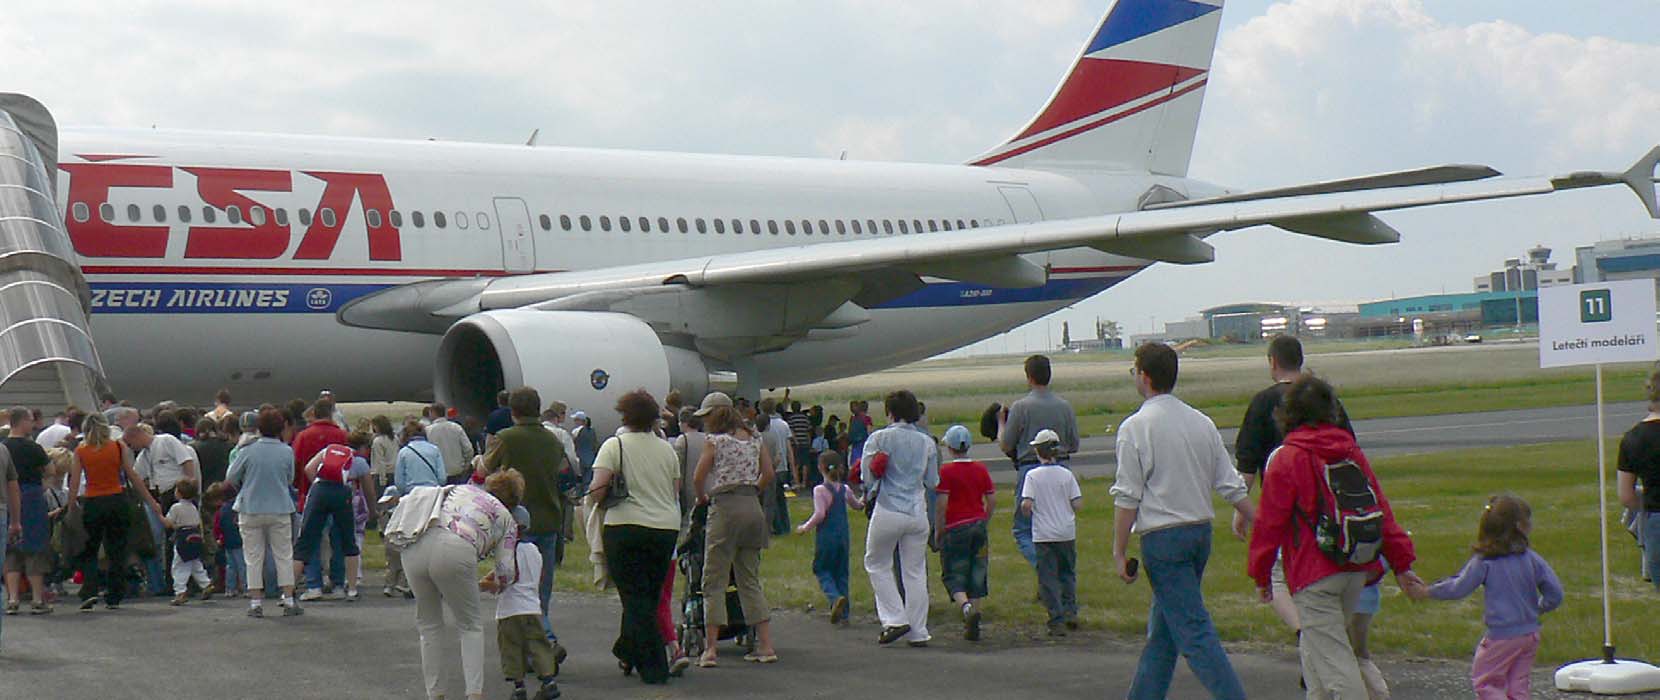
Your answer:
[0,583,1646,700]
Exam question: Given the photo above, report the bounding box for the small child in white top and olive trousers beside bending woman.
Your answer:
[478,506,559,700]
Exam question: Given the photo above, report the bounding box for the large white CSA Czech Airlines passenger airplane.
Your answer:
[0,0,1660,425]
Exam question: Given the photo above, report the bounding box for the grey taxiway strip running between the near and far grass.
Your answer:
[969,401,1648,483]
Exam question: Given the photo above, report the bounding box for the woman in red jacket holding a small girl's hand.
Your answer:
[1247,375,1424,698]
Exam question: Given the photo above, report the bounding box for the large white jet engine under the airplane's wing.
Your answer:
[433,309,709,435]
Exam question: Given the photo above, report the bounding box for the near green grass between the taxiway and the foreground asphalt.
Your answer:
[514,441,1660,665]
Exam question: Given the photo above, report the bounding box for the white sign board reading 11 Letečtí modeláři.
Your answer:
[1539,279,1660,367]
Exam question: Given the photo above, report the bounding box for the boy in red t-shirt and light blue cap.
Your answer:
[935,425,998,642]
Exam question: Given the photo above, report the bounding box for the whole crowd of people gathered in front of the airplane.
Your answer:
[0,337,1593,698]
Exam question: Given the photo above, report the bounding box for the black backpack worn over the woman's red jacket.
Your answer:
[1308,459,1383,566]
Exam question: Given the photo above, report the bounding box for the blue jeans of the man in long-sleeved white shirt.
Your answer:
[1129,523,1245,700]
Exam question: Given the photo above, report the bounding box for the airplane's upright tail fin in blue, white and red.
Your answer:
[971,0,1222,176]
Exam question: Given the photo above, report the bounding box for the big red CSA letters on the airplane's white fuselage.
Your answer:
[58,163,403,260]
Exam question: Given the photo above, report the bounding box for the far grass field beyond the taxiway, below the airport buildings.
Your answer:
[775,343,1647,435]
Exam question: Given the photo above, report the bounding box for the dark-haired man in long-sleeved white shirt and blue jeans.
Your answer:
[1112,343,1255,700]
